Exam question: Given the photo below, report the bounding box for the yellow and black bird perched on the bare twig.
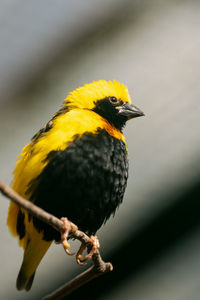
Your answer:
[7,80,144,291]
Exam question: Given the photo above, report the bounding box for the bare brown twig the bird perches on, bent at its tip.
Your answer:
[0,180,113,300]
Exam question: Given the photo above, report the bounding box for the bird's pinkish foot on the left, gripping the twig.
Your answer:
[61,218,78,255]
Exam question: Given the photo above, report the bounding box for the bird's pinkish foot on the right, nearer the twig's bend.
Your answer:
[76,235,100,265]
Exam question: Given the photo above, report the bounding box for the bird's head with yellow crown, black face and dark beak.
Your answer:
[64,80,144,130]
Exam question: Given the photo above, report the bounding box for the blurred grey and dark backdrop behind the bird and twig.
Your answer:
[0,0,200,300]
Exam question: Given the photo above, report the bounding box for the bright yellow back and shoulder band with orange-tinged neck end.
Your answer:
[12,109,124,198]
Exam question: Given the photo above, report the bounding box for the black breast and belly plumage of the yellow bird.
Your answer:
[29,129,128,241]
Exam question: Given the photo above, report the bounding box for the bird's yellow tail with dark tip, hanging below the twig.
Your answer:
[16,234,52,291]
